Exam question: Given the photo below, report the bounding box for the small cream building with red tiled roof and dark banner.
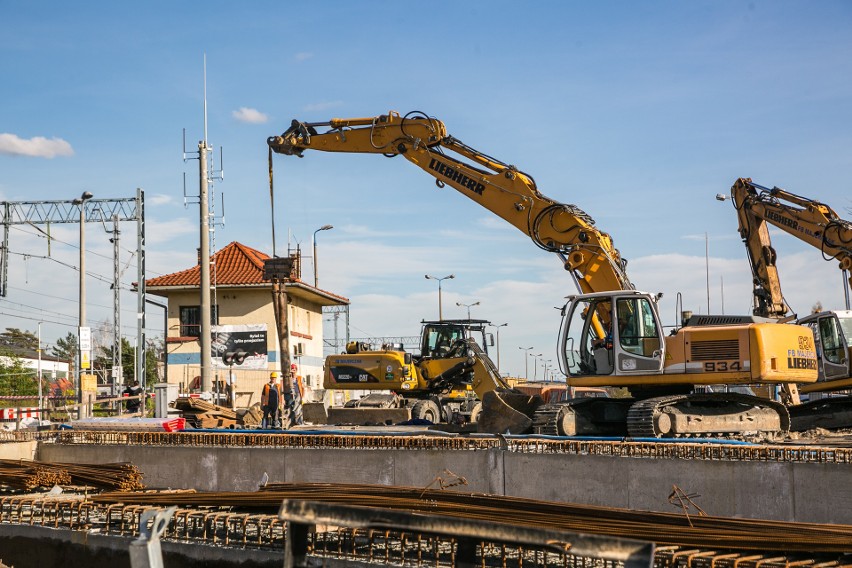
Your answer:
[146,242,349,405]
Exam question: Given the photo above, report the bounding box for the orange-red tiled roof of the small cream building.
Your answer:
[145,241,269,287]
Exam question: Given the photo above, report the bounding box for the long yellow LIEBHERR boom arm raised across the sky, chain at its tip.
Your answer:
[267,112,633,293]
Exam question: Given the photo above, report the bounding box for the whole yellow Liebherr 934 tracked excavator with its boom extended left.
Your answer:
[267,112,817,438]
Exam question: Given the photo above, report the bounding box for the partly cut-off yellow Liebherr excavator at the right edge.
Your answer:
[716,178,852,430]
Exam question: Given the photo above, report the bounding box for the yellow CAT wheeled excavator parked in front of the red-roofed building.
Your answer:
[323,319,538,431]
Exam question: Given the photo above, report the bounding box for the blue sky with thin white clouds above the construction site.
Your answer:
[0,0,852,376]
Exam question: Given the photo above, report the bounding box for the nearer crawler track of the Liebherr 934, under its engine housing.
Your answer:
[627,393,790,438]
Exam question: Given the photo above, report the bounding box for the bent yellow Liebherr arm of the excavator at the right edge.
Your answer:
[731,178,852,319]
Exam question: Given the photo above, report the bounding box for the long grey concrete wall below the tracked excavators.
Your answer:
[37,444,852,524]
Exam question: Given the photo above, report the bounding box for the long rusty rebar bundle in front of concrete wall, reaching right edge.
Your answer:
[92,483,852,553]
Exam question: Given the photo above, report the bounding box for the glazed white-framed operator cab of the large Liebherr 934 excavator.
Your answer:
[559,290,665,377]
